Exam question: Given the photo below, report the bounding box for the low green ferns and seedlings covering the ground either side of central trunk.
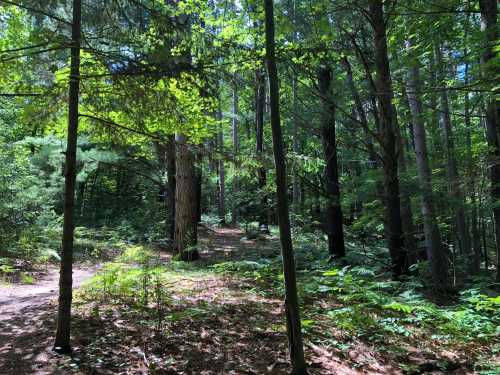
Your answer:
[76,231,500,374]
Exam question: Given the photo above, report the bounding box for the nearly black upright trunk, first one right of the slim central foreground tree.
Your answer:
[318,65,345,258]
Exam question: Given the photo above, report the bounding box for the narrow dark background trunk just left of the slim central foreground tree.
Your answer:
[255,70,269,233]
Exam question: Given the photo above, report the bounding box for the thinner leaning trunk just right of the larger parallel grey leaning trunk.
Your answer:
[434,44,471,259]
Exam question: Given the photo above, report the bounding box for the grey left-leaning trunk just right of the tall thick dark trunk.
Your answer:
[407,42,448,288]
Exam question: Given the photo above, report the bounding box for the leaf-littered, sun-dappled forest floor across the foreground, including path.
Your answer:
[0,228,498,375]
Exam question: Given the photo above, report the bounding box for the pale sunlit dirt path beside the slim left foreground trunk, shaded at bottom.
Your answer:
[0,267,100,375]
